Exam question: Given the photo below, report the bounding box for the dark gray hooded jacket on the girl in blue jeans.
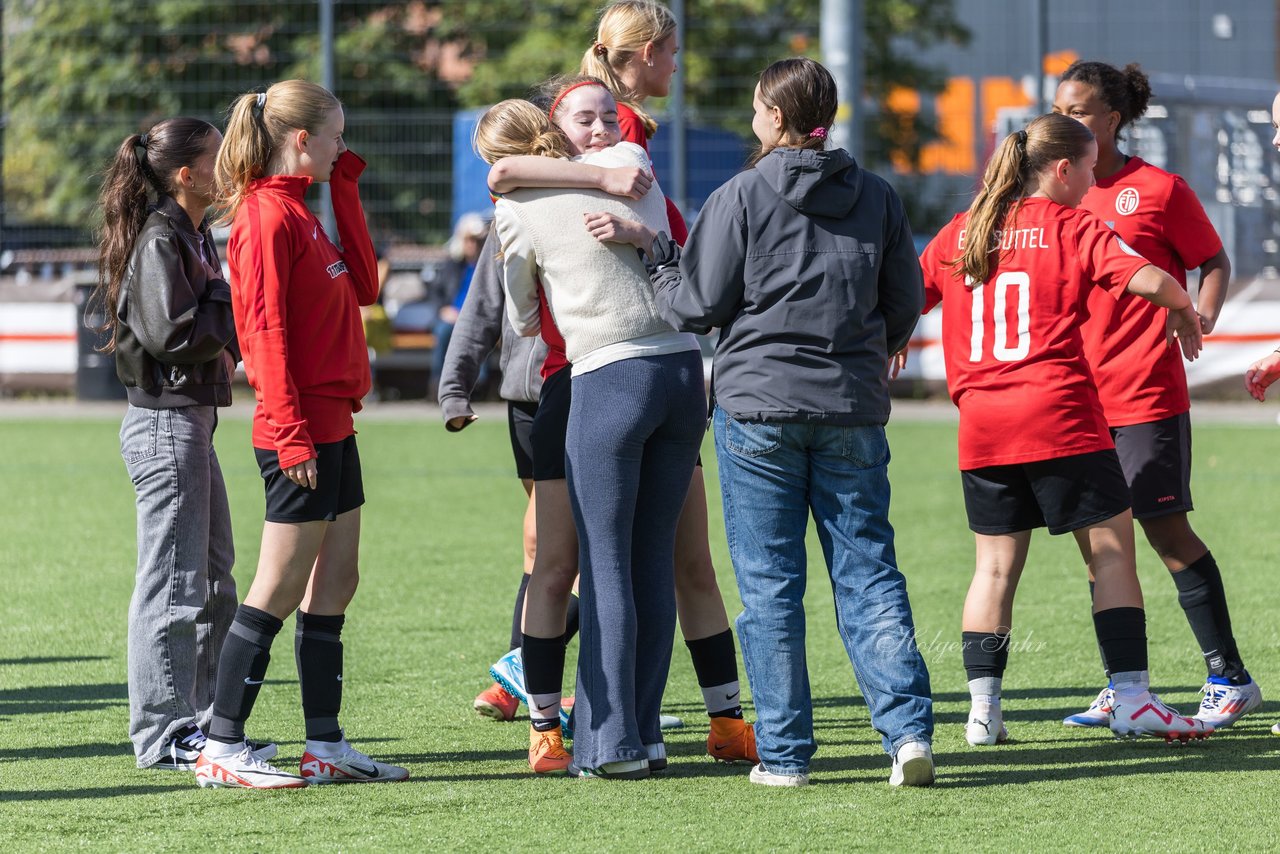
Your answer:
[654,149,924,425]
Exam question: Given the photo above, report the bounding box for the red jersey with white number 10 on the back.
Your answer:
[920,198,1147,470]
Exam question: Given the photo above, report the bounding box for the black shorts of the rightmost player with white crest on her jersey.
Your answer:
[1111,412,1194,519]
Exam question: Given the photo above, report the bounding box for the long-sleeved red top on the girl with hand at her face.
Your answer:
[227,151,378,469]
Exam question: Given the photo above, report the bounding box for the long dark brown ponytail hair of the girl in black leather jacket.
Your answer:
[88,118,218,352]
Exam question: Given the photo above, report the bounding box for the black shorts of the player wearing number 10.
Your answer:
[960,449,1129,534]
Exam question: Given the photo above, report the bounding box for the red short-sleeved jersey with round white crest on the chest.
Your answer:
[1080,157,1222,426]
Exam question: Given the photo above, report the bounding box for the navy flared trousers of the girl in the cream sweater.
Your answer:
[566,351,707,768]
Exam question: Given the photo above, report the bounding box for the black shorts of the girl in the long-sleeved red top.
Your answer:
[253,435,365,522]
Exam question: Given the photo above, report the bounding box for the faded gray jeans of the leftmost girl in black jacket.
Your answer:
[120,405,237,768]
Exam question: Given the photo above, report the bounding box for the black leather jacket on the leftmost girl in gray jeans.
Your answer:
[115,196,239,410]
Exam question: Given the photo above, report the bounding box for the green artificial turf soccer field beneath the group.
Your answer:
[0,410,1280,851]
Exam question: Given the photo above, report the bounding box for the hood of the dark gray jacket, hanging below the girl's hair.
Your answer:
[755,149,863,218]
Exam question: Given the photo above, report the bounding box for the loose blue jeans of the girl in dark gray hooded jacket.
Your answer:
[714,407,933,775]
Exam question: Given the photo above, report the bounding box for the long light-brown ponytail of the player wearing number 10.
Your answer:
[954,113,1093,287]
